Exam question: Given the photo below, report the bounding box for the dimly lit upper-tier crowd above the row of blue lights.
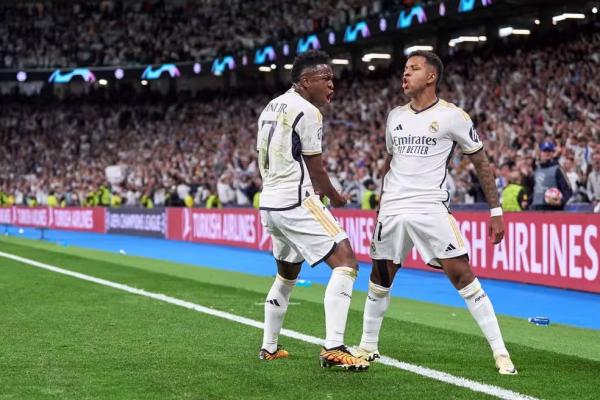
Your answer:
[0,0,432,68]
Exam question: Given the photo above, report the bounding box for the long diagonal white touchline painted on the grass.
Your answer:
[0,251,538,400]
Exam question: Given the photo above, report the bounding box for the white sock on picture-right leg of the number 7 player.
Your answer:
[325,267,356,349]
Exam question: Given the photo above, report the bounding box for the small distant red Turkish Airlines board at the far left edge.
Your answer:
[0,207,106,233]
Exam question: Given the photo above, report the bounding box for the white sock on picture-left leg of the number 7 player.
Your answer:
[262,274,296,353]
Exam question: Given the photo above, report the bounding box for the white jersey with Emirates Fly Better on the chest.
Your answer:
[379,99,483,215]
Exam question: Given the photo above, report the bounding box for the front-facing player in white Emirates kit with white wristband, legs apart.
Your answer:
[354,51,517,375]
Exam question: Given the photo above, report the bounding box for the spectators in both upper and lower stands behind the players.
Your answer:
[0,0,600,211]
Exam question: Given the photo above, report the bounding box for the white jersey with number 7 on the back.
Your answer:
[257,89,323,210]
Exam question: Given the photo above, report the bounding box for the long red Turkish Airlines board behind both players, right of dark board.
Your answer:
[168,209,600,293]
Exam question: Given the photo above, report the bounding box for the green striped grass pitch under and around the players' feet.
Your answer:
[0,238,600,399]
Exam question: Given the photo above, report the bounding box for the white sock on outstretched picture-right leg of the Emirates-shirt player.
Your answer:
[458,278,508,357]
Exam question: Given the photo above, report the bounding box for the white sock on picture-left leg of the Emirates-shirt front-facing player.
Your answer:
[360,281,390,352]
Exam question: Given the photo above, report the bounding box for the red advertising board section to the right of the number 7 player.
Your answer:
[333,210,600,293]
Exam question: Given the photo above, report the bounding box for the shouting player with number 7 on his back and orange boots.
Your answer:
[257,51,369,370]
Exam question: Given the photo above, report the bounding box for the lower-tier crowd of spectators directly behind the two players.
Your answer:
[0,22,600,207]
